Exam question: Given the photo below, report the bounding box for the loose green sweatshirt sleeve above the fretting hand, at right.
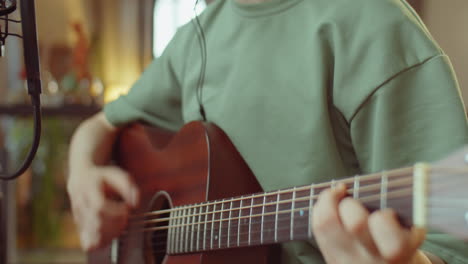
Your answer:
[350,55,468,264]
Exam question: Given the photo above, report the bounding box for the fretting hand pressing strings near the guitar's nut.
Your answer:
[312,185,430,264]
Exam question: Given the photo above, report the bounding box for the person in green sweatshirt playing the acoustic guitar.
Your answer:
[67,0,468,264]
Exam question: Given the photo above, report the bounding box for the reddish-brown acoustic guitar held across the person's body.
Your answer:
[88,122,468,264]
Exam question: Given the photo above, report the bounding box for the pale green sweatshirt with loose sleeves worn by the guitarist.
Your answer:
[105,0,468,263]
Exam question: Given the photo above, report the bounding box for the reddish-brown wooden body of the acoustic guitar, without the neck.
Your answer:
[88,122,279,264]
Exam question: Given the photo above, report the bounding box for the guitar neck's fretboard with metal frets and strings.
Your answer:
[167,167,413,254]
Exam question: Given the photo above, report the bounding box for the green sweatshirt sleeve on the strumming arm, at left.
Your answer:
[104,30,183,130]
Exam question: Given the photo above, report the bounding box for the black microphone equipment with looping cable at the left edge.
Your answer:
[0,0,41,180]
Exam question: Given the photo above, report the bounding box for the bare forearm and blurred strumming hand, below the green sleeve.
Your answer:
[67,113,138,250]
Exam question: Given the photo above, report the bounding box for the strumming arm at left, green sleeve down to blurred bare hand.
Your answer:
[68,21,185,250]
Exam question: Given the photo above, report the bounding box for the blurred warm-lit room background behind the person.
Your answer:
[0,0,468,264]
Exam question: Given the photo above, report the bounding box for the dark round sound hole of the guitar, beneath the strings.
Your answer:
[146,195,171,264]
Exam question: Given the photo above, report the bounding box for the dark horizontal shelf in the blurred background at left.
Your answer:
[0,104,101,118]
